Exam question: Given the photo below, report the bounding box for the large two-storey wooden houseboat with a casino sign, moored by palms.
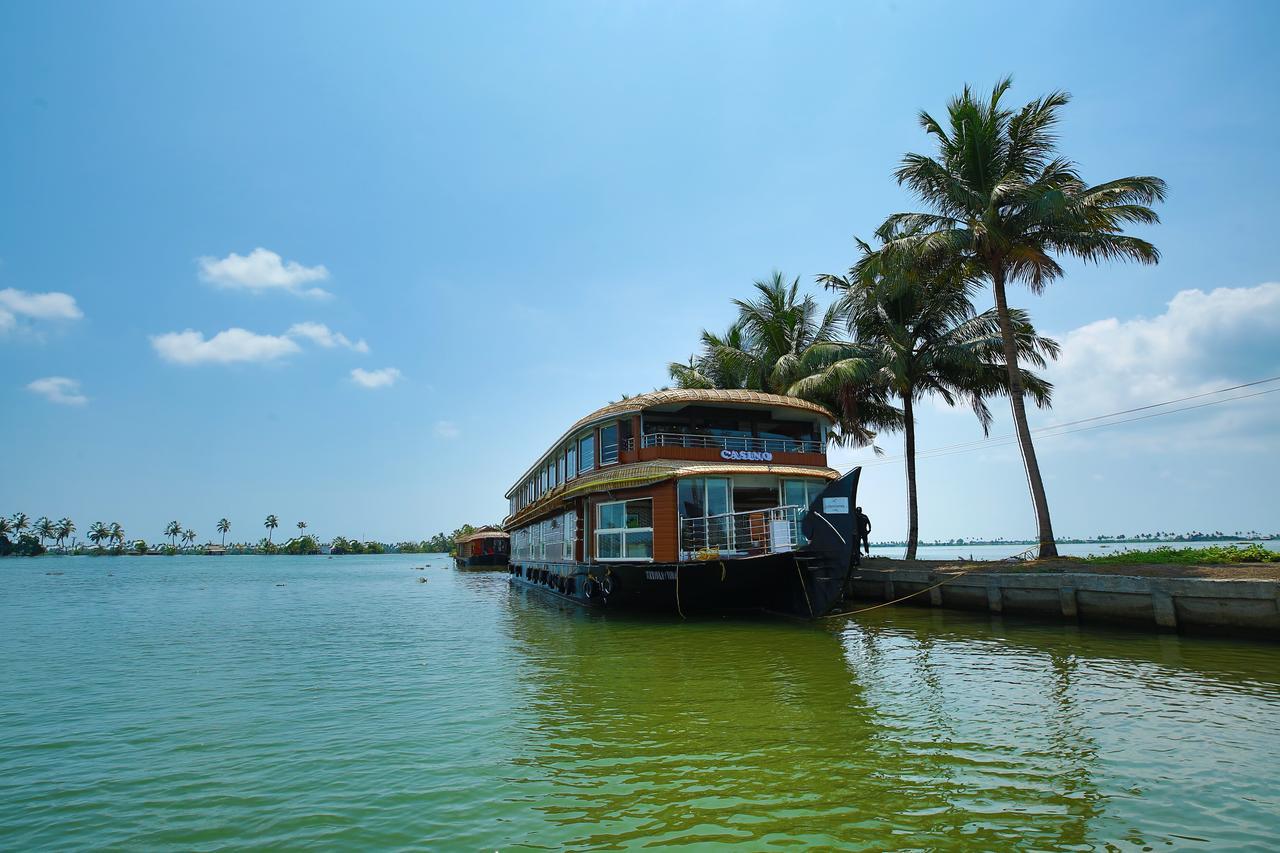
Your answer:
[503,389,860,617]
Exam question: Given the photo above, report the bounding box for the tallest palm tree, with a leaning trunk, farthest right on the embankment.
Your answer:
[877,78,1165,557]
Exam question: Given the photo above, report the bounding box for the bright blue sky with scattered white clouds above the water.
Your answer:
[0,0,1280,540]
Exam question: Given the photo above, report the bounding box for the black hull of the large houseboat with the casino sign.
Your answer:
[508,549,849,619]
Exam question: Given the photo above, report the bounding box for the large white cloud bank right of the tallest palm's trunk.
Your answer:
[1037,283,1280,443]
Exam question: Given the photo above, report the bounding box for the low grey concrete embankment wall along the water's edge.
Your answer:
[852,560,1280,640]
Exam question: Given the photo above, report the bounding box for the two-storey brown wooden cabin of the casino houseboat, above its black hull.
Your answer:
[503,389,840,570]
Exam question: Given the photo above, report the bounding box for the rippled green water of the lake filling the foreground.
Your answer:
[0,556,1280,850]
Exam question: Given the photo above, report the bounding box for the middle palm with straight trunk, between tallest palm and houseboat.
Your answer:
[819,241,1059,560]
